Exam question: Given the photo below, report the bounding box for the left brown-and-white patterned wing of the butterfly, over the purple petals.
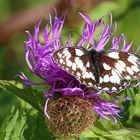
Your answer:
[53,47,96,87]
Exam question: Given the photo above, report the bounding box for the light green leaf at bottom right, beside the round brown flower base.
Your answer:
[79,119,140,140]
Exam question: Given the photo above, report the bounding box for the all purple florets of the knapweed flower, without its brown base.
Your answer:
[21,13,138,123]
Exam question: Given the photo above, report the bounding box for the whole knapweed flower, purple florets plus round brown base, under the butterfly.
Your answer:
[21,10,137,136]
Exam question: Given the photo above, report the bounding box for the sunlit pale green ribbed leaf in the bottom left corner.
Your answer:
[0,107,27,140]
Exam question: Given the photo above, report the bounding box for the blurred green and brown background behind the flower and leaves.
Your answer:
[0,0,140,128]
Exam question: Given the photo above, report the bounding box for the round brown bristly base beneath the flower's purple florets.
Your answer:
[48,96,96,137]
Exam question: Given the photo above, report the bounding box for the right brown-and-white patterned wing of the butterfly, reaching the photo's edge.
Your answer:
[98,51,140,92]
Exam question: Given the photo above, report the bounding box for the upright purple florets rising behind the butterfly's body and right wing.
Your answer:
[78,13,133,52]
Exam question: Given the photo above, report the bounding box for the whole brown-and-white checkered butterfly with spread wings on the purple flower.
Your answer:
[53,47,140,93]
